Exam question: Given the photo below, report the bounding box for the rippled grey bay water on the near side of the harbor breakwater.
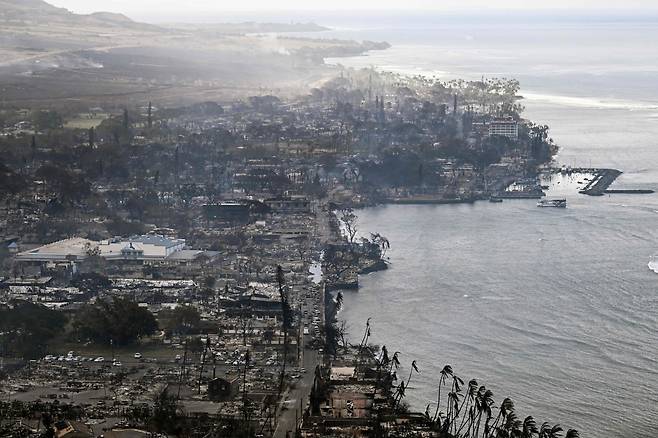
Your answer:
[340,196,658,437]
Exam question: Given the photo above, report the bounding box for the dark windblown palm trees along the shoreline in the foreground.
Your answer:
[357,319,579,438]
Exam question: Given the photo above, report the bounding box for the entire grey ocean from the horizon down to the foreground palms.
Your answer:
[310,14,658,438]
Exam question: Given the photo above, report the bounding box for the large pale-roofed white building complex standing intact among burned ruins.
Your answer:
[16,235,203,264]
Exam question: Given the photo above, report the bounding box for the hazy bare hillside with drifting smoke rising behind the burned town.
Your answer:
[0,0,385,109]
